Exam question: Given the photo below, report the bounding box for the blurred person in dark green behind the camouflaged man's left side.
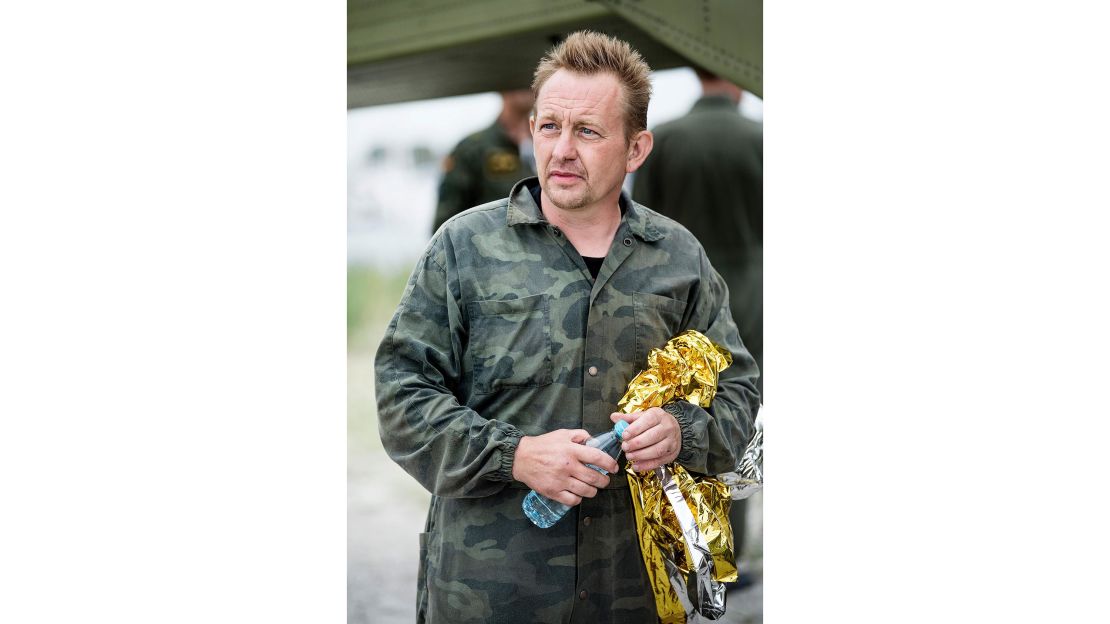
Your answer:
[432,89,535,233]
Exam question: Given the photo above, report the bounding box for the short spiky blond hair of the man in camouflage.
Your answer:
[532,30,652,140]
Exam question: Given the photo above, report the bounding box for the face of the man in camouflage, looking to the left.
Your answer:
[532,69,646,210]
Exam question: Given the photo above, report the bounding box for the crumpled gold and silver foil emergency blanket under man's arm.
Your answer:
[618,330,736,624]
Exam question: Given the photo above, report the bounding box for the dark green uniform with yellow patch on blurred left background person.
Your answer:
[432,121,535,232]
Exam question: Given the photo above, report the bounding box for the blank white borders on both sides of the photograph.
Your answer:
[0,2,1110,623]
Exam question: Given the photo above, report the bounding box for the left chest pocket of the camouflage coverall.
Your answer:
[467,294,552,394]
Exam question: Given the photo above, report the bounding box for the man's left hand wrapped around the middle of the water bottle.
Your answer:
[513,429,619,506]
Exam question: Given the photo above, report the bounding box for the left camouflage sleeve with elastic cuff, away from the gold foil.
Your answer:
[374,233,523,497]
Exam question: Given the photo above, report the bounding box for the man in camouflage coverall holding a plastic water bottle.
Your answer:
[374,32,759,624]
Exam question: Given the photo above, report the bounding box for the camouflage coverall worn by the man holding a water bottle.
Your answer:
[375,178,759,624]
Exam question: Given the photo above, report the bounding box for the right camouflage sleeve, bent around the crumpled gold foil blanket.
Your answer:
[664,243,759,474]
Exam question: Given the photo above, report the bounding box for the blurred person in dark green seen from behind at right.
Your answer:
[633,68,763,584]
